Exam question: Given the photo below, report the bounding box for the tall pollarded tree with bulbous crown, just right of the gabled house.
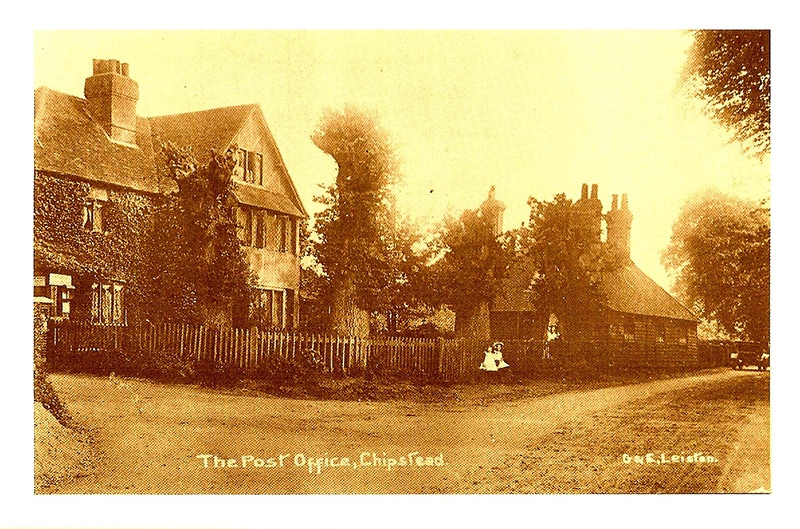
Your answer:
[312,106,398,336]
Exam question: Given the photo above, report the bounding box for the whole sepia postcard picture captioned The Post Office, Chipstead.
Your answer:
[32,29,772,508]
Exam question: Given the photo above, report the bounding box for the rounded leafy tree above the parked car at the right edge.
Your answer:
[663,189,770,343]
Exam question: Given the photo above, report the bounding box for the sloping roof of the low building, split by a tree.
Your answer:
[491,259,698,321]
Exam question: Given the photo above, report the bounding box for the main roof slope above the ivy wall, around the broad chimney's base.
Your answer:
[33,87,159,193]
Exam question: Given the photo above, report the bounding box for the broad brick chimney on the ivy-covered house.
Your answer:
[83,59,139,145]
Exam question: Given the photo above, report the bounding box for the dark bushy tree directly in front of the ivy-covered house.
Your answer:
[146,145,251,324]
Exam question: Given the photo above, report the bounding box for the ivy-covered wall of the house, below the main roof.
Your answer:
[33,171,157,320]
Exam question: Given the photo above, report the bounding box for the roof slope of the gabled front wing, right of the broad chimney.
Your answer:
[149,104,258,163]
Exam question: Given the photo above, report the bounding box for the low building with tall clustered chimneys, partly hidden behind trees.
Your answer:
[490,184,698,367]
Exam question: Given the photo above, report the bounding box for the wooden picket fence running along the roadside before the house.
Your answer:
[48,321,548,381]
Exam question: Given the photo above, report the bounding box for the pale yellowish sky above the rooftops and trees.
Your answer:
[34,31,769,288]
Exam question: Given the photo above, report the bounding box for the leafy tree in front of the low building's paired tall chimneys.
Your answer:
[517,194,617,341]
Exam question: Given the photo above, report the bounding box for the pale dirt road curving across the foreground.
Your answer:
[45,370,769,494]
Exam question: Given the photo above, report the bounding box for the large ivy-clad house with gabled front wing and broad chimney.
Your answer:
[34,60,307,328]
